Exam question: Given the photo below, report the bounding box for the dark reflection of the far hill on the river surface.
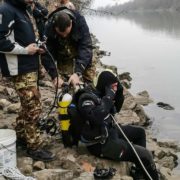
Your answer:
[88,11,180,39]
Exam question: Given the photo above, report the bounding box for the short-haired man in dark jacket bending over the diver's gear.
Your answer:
[44,7,95,87]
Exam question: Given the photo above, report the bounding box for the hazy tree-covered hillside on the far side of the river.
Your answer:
[101,0,180,14]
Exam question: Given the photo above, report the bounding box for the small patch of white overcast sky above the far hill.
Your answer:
[93,0,130,8]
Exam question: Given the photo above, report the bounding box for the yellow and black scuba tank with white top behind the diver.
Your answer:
[58,93,72,147]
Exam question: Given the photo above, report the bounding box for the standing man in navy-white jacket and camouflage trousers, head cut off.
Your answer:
[0,0,57,161]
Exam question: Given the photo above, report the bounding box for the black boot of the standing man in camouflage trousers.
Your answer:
[27,149,55,162]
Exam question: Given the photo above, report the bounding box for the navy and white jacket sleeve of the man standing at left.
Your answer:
[0,6,28,54]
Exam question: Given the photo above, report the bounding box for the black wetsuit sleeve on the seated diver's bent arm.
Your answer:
[78,96,113,125]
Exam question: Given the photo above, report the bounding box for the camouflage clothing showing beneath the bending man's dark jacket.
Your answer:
[57,38,96,82]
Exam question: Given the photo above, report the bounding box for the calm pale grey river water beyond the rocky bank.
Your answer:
[86,0,180,146]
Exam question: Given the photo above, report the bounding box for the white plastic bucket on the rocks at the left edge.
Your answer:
[0,129,17,173]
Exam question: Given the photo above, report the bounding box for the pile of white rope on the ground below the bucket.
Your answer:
[2,167,36,180]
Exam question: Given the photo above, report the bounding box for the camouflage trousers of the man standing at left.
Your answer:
[12,72,42,149]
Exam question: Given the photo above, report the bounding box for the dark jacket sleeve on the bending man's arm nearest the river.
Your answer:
[75,13,92,73]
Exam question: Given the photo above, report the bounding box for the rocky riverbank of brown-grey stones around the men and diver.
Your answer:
[0,37,180,180]
